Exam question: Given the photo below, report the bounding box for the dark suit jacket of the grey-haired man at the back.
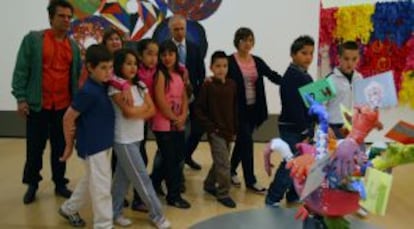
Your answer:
[185,39,206,95]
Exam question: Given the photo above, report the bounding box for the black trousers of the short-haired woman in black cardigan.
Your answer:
[231,106,256,186]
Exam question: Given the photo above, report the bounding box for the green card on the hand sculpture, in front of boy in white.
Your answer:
[299,77,336,107]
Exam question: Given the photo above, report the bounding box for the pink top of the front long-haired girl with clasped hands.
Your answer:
[152,72,185,131]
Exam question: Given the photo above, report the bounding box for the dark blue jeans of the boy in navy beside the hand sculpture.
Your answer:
[266,127,304,204]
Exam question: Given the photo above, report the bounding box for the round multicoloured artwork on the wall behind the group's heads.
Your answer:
[69,0,222,56]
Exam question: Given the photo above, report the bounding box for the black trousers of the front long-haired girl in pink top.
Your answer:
[154,131,184,201]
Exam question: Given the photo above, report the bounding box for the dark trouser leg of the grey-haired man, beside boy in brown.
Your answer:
[185,103,204,160]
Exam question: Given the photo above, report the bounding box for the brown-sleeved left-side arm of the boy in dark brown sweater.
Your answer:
[194,82,216,133]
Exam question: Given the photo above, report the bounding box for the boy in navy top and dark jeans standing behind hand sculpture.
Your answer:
[265,36,315,207]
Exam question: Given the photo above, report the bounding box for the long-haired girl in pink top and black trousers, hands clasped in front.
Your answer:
[151,40,190,208]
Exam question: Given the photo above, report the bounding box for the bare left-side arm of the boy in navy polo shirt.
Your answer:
[59,106,80,161]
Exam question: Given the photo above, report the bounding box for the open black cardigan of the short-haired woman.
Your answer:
[228,55,282,127]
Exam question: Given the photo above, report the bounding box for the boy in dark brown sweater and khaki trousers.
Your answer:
[194,51,237,208]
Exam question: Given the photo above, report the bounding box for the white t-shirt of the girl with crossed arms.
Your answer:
[108,82,148,144]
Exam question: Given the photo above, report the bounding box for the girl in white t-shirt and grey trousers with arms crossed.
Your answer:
[109,49,170,228]
